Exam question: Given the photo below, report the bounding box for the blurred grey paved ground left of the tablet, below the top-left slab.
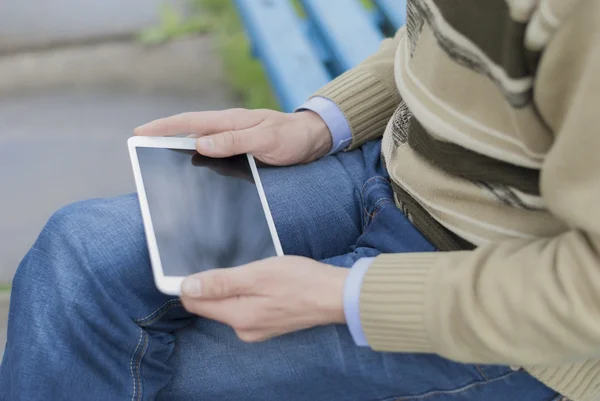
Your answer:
[0,33,235,352]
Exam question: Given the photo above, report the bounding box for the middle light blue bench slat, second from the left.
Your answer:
[301,0,384,74]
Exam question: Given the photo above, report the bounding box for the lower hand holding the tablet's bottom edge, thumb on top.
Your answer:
[181,256,348,342]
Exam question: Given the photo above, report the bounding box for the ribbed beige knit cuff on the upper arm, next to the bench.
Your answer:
[313,69,400,149]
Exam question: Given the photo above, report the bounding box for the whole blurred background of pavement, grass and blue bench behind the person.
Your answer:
[0,0,404,356]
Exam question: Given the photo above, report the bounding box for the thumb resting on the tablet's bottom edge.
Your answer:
[181,267,253,299]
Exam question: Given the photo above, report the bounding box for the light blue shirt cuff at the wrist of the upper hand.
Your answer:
[296,96,352,155]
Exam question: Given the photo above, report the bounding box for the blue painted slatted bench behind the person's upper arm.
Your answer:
[235,0,406,111]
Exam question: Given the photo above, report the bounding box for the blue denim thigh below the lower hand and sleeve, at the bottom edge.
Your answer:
[158,319,556,401]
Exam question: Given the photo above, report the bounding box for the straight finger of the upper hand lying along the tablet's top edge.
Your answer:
[134,109,262,136]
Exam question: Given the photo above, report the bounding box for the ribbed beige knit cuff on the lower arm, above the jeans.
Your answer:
[360,253,437,353]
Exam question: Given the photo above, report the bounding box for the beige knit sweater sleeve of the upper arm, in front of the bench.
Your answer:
[313,28,405,149]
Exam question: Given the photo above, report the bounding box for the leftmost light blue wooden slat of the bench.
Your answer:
[235,0,332,111]
